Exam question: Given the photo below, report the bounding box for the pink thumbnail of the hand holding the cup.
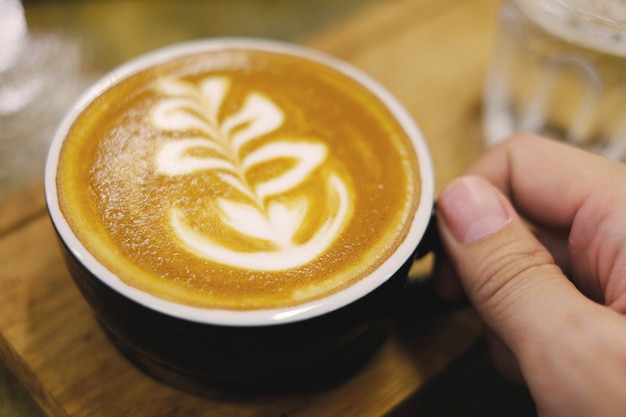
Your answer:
[437,177,510,244]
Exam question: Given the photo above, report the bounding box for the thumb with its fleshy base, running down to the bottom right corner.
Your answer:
[437,176,626,416]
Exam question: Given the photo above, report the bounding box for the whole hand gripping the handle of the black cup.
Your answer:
[434,134,626,417]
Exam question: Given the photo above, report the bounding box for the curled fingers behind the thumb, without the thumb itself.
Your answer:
[469,135,626,311]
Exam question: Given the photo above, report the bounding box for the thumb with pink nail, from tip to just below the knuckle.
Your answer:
[437,177,580,353]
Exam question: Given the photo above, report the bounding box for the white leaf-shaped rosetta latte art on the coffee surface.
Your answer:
[150,76,352,271]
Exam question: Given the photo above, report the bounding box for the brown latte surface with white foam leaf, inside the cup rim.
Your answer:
[57,43,421,310]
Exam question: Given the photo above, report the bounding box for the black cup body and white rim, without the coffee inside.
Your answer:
[45,39,436,389]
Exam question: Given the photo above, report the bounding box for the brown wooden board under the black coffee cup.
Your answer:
[0,0,508,417]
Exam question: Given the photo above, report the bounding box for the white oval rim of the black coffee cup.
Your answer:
[44,38,434,327]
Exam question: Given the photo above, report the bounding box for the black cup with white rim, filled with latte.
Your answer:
[45,38,434,384]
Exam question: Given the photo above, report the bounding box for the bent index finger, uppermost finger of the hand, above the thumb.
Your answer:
[469,134,626,229]
